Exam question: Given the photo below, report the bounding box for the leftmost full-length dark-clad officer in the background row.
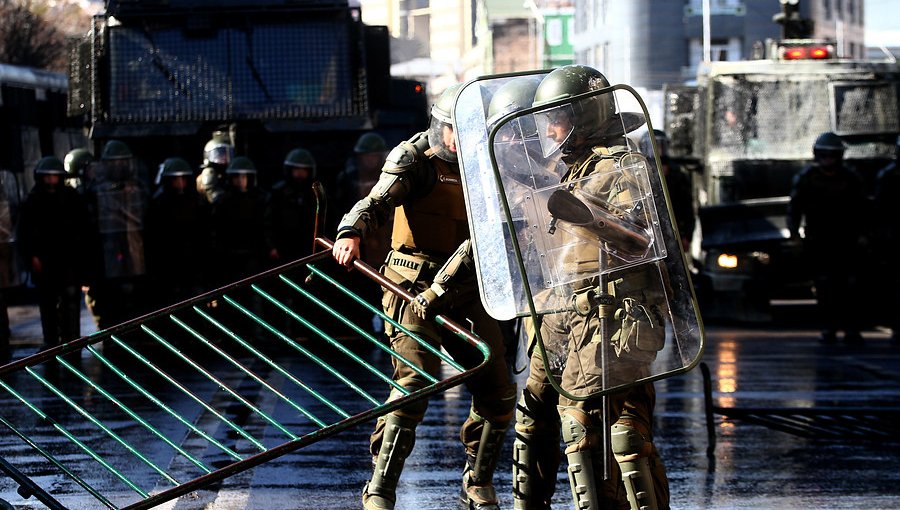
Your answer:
[18,156,93,349]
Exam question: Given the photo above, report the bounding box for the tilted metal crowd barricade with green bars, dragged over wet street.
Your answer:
[0,238,491,509]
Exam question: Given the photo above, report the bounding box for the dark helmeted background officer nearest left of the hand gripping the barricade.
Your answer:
[265,147,316,264]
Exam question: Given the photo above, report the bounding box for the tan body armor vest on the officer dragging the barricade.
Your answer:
[391,151,469,256]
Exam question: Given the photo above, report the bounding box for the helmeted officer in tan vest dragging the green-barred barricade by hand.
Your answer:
[333,85,515,509]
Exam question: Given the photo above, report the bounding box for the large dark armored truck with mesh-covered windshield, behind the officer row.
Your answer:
[68,0,427,189]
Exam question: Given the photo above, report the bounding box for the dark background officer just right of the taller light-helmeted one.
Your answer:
[212,156,269,284]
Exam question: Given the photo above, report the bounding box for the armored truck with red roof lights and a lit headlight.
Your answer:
[664,26,900,320]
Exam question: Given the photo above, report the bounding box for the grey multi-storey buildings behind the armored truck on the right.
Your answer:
[574,0,865,90]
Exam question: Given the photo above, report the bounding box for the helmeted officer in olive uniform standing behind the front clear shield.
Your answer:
[513,65,669,510]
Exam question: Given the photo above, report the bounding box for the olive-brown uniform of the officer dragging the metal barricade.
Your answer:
[337,126,515,508]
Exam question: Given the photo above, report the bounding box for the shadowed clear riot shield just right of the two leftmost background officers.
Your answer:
[92,158,148,278]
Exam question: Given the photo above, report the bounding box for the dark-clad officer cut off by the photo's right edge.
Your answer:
[875,136,900,344]
